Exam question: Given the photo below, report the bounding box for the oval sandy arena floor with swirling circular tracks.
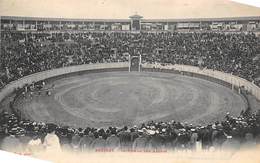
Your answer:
[0,63,252,127]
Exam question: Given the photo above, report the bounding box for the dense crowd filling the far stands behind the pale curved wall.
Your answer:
[0,31,260,87]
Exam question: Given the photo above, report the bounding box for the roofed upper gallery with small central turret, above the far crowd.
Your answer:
[1,14,260,32]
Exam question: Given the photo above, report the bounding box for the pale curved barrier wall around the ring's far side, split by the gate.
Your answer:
[0,62,260,102]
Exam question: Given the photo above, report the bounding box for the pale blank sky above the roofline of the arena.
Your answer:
[0,0,260,19]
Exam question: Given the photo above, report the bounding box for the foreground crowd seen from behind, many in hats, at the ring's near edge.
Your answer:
[0,110,260,152]
